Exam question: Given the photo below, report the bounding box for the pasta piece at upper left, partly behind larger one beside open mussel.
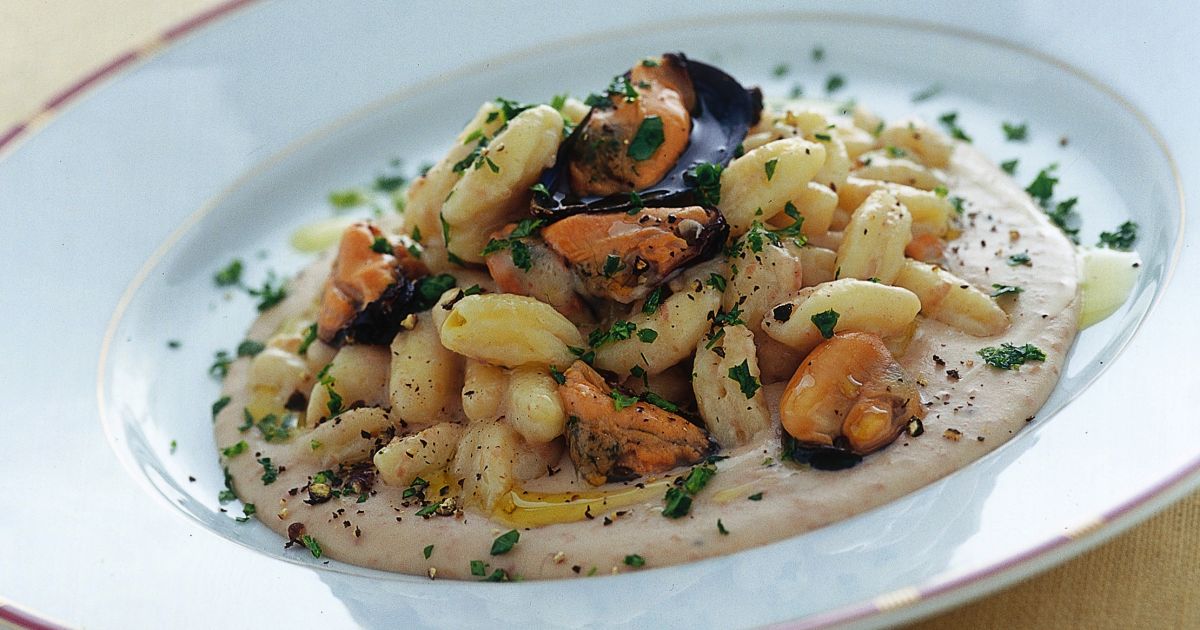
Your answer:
[404,101,505,271]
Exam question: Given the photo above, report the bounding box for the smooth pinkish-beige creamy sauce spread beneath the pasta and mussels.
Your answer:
[215,145,1080,578]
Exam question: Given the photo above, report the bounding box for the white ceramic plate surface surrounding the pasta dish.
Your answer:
[0,2,1200,628]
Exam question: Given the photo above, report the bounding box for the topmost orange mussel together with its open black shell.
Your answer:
[533,53,762,221]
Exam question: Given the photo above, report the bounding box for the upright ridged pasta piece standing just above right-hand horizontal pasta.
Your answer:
[836,191,912,284]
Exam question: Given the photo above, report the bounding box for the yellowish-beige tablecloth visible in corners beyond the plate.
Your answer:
[0,0,1200,630]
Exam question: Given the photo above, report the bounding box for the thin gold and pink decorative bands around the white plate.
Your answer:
[7,0,1200,628]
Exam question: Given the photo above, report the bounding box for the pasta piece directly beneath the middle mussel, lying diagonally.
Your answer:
[595,265,721,374]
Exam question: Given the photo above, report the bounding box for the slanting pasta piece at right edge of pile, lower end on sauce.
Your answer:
[895,260,1009,337]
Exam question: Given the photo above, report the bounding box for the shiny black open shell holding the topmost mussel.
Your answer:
[533,53,762,220]
